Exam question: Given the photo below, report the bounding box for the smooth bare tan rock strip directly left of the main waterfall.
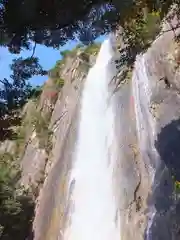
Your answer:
[34,54,87,240]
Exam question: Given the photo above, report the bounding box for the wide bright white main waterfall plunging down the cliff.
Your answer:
[64,37,120,240]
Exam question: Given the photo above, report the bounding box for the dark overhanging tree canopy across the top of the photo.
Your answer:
[0,0,180,53]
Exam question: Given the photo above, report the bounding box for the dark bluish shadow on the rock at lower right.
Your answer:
[146,120,180,240]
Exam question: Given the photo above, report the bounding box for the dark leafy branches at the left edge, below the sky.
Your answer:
[0,75,42,141]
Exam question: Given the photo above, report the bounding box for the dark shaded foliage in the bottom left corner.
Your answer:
[0,189,35,240]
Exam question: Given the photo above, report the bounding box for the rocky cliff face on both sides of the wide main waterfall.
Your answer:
[1,19,180,240]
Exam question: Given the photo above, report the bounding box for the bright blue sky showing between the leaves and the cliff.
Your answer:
[0,36,106,86]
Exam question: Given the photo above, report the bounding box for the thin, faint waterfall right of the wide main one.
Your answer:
[132,54,157,240]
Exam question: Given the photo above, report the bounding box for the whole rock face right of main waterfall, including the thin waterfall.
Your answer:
[114,17,180,240]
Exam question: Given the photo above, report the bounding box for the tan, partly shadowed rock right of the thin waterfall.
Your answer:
[142,24,180,239]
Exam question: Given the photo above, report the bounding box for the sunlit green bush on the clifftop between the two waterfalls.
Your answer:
[120,9,161,66]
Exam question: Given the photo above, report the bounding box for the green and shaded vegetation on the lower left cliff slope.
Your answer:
[0,94,52,240]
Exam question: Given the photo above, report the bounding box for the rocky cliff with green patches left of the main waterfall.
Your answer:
[0,46,98,239]
